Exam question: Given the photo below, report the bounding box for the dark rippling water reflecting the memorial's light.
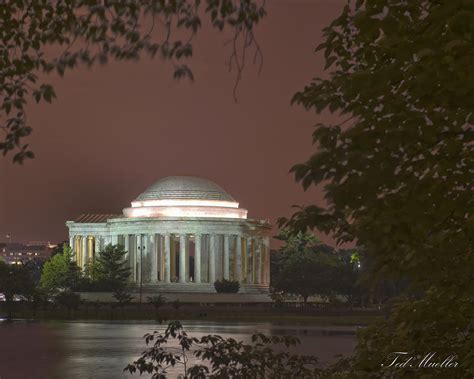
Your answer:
[0,321,355,379]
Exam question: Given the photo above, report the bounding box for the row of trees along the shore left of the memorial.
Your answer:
[0,243,133,318]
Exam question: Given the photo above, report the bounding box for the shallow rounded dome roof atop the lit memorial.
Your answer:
[135,176,235,202]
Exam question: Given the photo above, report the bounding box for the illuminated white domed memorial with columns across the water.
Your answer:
[66,176,271,293]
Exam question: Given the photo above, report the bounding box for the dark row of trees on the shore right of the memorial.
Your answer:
[271,230,406,307]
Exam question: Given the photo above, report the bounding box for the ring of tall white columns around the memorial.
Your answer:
[70,233,270,285]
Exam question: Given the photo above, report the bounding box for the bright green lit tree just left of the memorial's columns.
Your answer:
[40,245,81,294]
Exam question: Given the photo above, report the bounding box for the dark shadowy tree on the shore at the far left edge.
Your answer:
[0,261,34,319]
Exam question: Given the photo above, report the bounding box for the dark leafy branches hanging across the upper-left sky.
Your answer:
[0,0,265,163]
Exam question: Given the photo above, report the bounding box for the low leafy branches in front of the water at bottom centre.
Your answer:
[124,321,324,379]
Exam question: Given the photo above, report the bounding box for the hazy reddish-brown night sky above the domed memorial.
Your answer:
[0,0,344,246]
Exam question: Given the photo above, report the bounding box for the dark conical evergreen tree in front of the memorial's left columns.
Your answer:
[95,244,130,291]
